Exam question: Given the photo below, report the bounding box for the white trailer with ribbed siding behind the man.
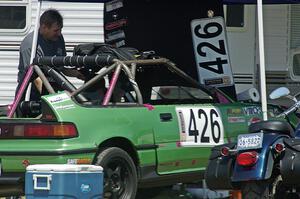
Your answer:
[0,0,104,104]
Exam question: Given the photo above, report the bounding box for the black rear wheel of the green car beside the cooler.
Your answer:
[96,147,137,199]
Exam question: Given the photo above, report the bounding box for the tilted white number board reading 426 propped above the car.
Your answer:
[191,17,233,87]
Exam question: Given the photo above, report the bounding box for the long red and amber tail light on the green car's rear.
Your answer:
[0,123,78,139]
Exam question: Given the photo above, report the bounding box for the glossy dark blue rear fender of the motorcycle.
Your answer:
[232,132,288,182]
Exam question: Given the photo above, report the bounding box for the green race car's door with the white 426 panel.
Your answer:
[154,104,224,174]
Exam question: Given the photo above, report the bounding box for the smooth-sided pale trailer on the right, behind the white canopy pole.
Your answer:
[224,4,300,98]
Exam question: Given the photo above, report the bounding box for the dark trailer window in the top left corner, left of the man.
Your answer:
[0,6,26,29]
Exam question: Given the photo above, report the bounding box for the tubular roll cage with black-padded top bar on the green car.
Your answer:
[8,55,232,117]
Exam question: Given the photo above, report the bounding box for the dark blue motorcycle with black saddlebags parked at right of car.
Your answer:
[205,87,300,199]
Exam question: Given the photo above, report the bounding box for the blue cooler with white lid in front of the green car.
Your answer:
[25,164,103,199]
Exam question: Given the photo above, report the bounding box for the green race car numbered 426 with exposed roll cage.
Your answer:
[0,49,288,199]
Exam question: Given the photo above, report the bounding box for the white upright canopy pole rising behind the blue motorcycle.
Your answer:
[257,0,268,120]
